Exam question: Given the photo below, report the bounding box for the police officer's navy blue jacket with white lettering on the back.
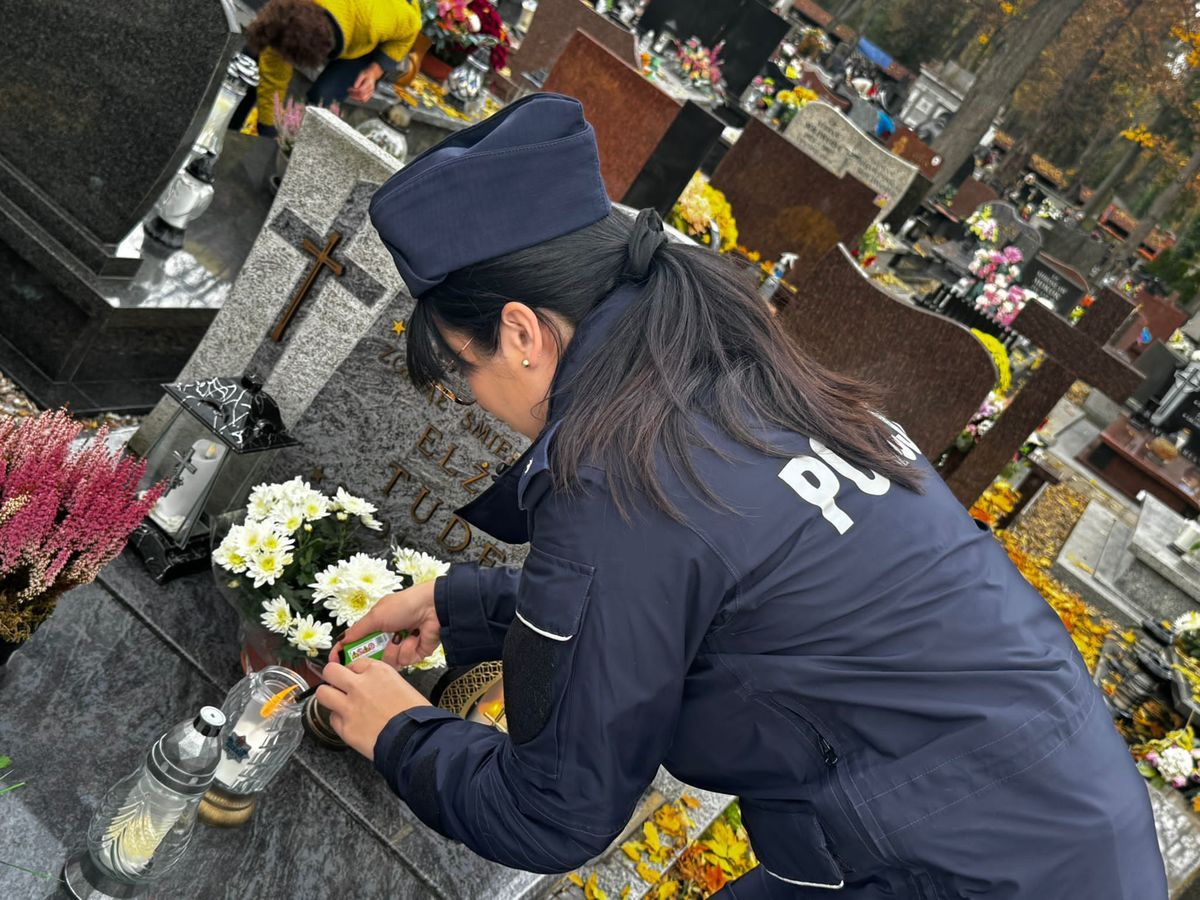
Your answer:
[374,289,1166,900]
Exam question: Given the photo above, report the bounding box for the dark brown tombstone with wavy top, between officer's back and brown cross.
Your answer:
[777,247,996,460]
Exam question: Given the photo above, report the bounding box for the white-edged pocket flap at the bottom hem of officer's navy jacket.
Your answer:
[742,800,846,890]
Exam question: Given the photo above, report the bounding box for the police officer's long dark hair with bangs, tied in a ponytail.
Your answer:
[408,211,920,517]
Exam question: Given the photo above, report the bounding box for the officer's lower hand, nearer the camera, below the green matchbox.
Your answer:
[317,659,430,761]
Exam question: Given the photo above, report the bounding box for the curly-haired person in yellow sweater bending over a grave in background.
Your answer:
[246,0,421,136]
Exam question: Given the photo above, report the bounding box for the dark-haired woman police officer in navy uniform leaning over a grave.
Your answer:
[318,95,1166,900]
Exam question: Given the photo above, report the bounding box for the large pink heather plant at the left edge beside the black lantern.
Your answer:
[0,409,163,642]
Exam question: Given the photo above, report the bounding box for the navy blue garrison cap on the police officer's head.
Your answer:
[371,94,612,298]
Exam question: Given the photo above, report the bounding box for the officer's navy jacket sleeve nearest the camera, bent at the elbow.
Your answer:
[374,470,736,872]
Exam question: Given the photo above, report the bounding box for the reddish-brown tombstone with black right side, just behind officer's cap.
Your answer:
[544,32,722,206]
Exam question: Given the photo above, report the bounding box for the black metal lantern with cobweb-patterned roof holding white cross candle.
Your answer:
[130,376,296,583]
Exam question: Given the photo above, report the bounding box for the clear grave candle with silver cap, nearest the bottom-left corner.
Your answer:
[64,707,224,900]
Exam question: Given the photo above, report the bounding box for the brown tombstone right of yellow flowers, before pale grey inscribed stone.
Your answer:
[713,119,880,277]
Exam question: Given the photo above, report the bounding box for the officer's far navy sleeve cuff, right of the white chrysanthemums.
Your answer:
[433,565,521,666]
